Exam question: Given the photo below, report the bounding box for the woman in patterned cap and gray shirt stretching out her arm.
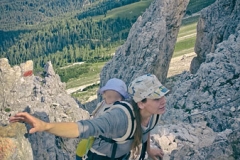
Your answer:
[9,74,169,160]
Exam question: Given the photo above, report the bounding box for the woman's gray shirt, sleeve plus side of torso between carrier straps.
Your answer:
[78,105,132,157]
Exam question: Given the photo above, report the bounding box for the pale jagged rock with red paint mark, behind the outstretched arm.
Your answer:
[0,59,89,160]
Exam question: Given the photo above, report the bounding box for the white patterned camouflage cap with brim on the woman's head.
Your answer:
[128,74,169,103]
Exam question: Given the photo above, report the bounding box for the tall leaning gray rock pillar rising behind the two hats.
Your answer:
[100,0,189,86]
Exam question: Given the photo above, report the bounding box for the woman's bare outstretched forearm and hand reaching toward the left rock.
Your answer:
[9,112,79,138]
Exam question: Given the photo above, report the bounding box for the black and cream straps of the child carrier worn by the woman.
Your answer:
[76,101,159,160]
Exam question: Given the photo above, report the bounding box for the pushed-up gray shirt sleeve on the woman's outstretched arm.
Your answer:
[78,108,128,138]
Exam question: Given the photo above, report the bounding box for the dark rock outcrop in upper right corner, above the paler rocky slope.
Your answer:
[190,0,240,73]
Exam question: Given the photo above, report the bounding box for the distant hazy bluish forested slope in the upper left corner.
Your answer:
[0,0,92,30]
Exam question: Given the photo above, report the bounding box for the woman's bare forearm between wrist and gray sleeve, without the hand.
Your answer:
[45,122,79,138]
